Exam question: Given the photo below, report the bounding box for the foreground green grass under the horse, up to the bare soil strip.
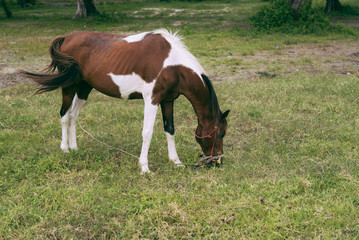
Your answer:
[0,74,359,239]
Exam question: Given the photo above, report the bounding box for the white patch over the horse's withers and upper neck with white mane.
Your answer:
[153,29,205,83]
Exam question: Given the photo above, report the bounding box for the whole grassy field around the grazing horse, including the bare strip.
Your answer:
[0,0,359,239]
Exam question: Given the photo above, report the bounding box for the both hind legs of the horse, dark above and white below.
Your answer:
[60,81,92,152]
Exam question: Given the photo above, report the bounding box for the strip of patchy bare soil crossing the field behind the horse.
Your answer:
[0,41,359,88]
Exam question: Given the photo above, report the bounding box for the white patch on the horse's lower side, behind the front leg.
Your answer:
[107,73,146,98]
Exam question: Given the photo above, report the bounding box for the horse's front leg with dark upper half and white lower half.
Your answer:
[161,101,182,166]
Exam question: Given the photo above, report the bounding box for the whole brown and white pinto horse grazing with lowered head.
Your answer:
[21,30,229,173]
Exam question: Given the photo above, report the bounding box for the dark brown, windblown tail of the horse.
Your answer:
[20,37,81,95]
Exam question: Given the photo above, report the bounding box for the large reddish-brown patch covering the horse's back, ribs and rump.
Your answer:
[57,32,171,97]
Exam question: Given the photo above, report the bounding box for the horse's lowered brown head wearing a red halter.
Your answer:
[195,110,229,157]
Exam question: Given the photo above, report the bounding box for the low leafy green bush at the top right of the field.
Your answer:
[250,0,335,33]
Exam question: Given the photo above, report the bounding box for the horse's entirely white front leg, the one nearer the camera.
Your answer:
[140,95,158,174]
